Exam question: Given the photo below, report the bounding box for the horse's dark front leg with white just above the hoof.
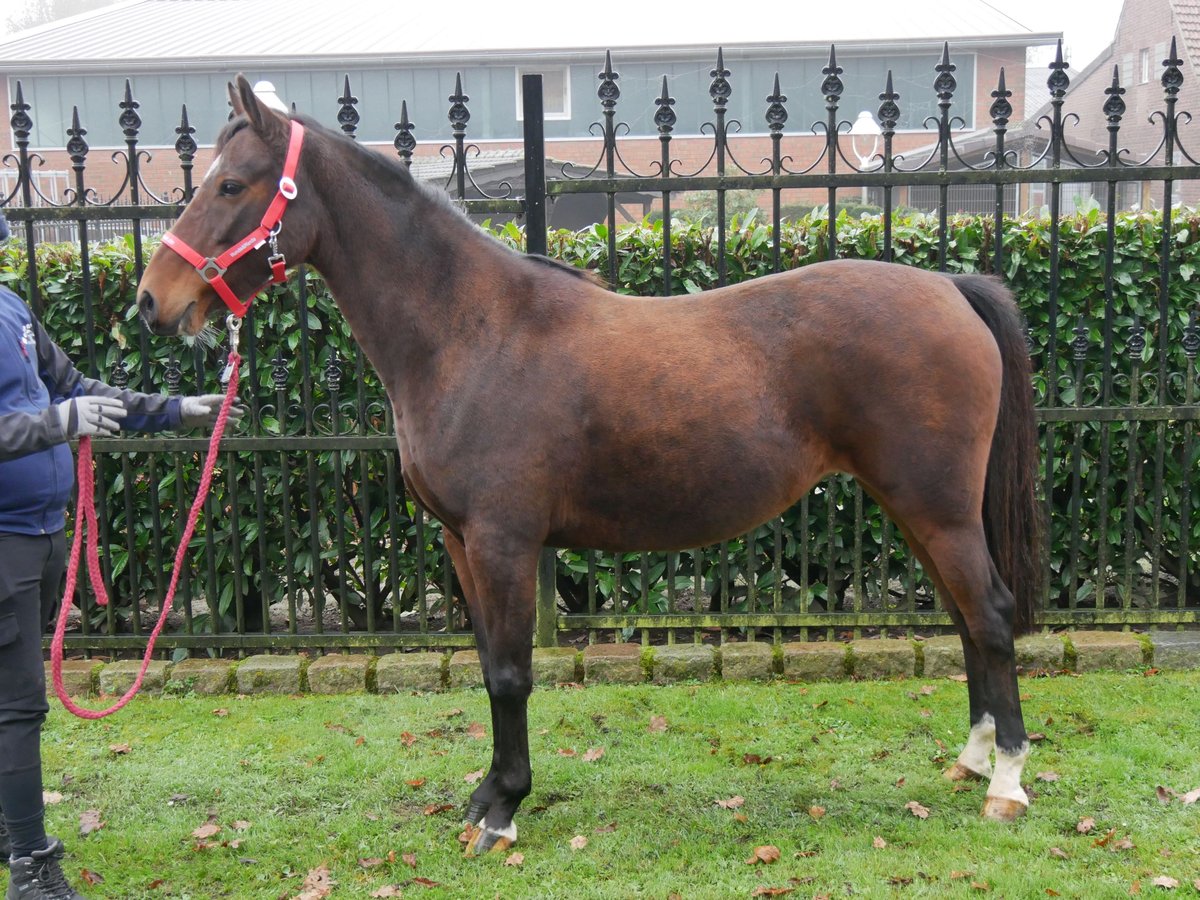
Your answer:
[451,532,541,856]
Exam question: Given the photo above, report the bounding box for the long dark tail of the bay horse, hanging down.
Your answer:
[952,275,1042,635]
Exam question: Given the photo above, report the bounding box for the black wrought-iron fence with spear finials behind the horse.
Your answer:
[0,43,1200,652]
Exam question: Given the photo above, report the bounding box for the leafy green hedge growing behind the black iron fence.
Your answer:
[0,211,1200,630]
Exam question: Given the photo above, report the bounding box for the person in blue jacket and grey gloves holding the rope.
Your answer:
[0,211,241,900]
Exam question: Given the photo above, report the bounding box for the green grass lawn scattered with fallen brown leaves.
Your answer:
[21,672,1200,900]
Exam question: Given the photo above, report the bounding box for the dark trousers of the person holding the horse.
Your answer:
[0,532,66,850]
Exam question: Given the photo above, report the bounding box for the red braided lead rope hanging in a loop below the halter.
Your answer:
[50,350,241,719]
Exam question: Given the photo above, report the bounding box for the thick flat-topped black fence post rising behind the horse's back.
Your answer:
[521,74,558,647]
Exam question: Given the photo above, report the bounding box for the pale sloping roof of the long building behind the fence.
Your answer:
[0,0,1058,71]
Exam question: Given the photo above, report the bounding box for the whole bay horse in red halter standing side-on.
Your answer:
[137,76,1039,854]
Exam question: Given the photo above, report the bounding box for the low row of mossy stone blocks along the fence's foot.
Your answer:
[47,631,1200,696]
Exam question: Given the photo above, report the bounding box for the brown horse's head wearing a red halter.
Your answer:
[137,74,316,335]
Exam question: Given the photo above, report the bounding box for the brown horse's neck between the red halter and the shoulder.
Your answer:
[300,144,520,388]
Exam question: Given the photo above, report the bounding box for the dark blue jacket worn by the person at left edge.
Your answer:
[0,287,180,534]
